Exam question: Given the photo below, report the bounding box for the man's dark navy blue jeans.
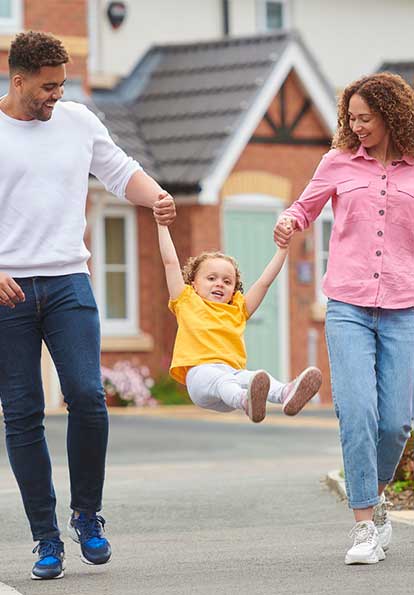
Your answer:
[0,273,108,541]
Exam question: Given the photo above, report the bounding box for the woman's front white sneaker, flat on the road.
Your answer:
[345,521,385,564]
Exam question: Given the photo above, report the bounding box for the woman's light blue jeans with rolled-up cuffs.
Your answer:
[326,300,414,509]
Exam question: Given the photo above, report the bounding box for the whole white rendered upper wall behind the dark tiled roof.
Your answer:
[89,0,414,88]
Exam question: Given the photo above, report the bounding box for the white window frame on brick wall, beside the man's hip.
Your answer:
[88,193,139,337]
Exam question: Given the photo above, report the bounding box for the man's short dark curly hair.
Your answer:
[9,31,69,74]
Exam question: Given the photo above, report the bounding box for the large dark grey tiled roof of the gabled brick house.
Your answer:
[93,32,334,189]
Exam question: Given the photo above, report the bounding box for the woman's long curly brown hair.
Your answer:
[332,72,414,156]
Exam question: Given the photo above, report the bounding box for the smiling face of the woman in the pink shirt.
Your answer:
[348,93,390,153]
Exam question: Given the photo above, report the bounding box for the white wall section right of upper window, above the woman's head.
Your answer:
[291,0,414,88]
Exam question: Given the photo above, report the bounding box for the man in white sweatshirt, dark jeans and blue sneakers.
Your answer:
[0,31,175,579]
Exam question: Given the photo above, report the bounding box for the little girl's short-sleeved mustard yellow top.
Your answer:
[168,285,249,384]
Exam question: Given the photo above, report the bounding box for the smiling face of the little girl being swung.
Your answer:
[192,258,236,304]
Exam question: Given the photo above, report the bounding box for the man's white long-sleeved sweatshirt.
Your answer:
[0,101,141,278]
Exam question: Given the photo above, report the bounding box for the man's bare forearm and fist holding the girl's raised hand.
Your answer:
[125,175,176,225]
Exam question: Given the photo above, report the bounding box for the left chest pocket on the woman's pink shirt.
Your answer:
[334,179,378,222]
